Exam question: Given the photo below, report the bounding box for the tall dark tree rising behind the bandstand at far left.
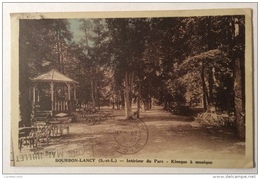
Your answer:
[19,19,71,126]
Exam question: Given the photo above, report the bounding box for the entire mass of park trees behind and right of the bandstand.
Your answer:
[20,16,245,138]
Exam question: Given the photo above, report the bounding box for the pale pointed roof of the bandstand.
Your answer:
[32,69,78,83]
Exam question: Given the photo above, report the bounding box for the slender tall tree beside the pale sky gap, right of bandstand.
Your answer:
[77,19,109,109]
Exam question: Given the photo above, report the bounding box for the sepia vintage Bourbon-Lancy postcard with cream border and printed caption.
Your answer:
[10,9,254,168]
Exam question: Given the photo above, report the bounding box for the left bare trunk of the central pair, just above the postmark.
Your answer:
[124,72,133,119]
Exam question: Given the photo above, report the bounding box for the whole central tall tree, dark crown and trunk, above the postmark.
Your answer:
[107,18,147,119]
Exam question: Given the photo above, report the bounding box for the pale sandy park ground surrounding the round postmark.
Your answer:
[18,107,245,163]
